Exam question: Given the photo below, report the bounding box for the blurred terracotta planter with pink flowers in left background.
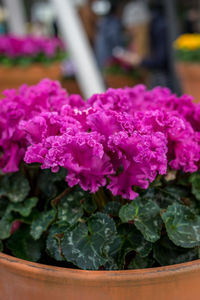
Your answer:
[0,35,65,94]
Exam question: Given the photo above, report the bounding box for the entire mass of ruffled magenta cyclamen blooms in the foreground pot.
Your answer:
[0,80,200,199]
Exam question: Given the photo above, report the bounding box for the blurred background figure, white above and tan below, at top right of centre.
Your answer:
[122,0,150,57]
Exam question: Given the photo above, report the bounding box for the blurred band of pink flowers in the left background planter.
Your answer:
[0,35,64,59]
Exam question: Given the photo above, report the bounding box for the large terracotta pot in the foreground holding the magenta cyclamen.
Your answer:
[0,254,200,300]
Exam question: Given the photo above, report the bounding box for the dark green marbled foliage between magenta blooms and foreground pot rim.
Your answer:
[0,171,200,270]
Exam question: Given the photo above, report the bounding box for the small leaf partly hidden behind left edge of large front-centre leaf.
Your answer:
[46,224,69,261]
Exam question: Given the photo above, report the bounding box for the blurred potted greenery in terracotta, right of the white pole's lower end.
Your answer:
[104,58,145,89]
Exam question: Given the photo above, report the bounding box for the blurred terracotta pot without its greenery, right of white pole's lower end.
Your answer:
[105,74,144,89]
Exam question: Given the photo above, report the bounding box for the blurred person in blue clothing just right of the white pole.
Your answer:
[94,0,125,69]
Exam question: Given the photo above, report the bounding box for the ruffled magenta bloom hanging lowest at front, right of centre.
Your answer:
[108,132,167,200]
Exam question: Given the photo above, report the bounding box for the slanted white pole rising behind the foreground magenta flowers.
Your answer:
[51,0,105,98]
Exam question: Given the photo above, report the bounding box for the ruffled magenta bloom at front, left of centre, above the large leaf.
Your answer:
[25,132,113,192]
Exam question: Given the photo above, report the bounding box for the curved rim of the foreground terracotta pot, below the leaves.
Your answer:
[0,253,200,286]
